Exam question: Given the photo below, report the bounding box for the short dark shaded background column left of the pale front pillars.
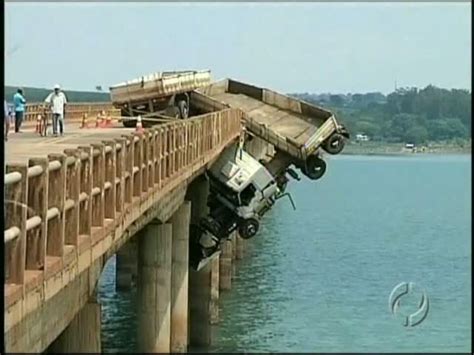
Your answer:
[115,236,138,291]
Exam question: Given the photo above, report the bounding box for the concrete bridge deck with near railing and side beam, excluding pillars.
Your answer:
[4,109,242,352]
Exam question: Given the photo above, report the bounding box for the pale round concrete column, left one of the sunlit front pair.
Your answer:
[137,221,172,353]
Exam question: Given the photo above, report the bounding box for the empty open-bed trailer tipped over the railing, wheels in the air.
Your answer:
[191,79,349,180]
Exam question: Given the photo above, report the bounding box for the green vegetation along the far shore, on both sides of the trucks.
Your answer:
[5,85,471,154]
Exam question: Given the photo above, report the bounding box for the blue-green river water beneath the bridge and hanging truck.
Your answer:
[99,155,471,352]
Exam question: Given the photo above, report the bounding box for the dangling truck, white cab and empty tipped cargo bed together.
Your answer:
[190,79,349,270]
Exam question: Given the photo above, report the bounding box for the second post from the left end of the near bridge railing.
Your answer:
[26,158,49,270]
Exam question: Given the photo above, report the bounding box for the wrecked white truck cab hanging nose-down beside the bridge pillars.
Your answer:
[190,144,294,270]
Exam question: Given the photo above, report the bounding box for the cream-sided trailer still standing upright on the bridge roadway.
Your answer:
[110,70,211,127]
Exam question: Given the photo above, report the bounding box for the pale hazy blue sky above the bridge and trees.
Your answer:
[5,3,471,93]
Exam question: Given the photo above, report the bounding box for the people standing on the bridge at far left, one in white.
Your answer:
[4,85,67,140]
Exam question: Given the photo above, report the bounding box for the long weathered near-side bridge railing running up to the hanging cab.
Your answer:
[4,109,242,293]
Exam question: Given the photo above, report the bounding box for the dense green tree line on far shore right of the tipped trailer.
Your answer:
[292,85,471,144]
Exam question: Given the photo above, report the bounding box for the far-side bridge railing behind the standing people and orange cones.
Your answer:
[24,102,114,122]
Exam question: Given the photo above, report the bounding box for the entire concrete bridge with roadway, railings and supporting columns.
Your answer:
[4,104,260,352]
